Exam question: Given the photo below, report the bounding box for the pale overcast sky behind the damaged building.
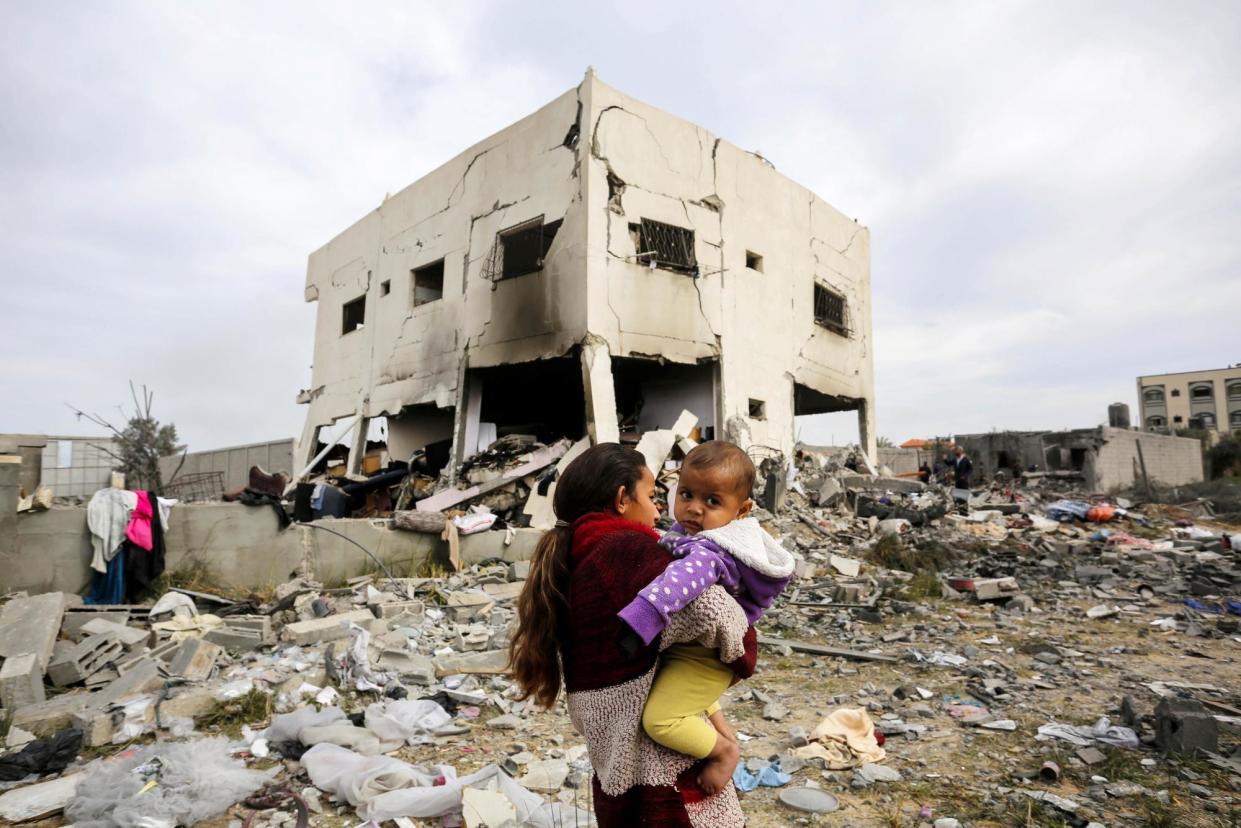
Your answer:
[0,0,1241,449]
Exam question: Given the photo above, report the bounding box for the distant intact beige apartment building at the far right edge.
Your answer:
[1138,362,1241,433]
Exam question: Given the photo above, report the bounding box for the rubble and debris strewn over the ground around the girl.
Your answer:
[0,436,1241,828]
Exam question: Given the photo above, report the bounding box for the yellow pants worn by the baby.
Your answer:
[642,644,732,758]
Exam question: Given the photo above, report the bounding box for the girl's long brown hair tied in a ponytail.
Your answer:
[509,443,647,708]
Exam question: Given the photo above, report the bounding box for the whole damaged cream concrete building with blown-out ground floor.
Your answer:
[295,71,875,470]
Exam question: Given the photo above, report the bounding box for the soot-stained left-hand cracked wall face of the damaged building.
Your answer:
[298,89,586,459]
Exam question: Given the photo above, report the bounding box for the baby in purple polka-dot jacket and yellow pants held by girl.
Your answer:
[618,441,793,794]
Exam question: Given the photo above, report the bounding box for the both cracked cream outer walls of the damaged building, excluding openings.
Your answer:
[299,71,875,466]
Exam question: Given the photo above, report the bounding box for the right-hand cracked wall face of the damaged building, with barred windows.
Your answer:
[583,76,875,457]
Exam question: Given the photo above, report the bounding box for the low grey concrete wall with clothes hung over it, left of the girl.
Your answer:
[0,503,542,593]
